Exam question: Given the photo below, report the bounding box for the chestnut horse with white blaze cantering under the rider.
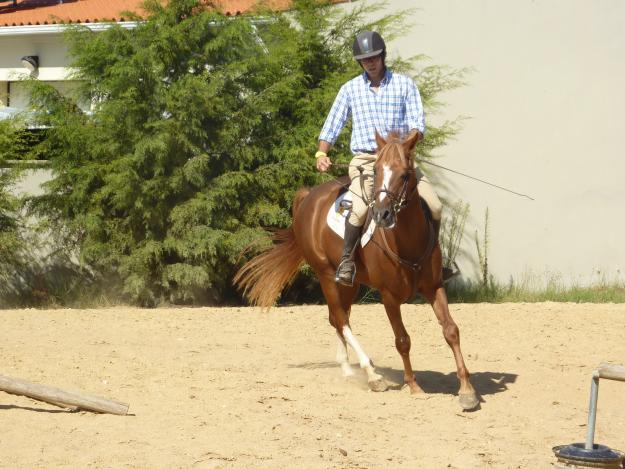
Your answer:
[234,133,479,410]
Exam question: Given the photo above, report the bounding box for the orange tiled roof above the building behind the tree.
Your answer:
[0,0,300,27]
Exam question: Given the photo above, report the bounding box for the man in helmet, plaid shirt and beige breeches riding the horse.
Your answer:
[315,31,447,286]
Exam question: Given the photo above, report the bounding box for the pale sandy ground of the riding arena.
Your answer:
[0,303,625,469]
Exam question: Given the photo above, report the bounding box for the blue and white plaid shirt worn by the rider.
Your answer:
[319,70,425,154]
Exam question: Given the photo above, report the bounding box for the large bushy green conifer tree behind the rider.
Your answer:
[22,0,466,305]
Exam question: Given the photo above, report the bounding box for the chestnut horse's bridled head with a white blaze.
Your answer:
[373,132,419,228]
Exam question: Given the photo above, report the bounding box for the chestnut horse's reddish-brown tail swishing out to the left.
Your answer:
[233,189,309,309]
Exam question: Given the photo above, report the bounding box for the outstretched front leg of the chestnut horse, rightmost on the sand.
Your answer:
[425,287,480,410]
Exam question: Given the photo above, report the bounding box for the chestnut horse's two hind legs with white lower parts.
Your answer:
[319,272,388,391]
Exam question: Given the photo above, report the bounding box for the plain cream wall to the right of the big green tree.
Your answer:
[348,0,625,283]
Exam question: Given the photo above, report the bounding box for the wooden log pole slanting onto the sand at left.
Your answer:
[0,375,128,415]
